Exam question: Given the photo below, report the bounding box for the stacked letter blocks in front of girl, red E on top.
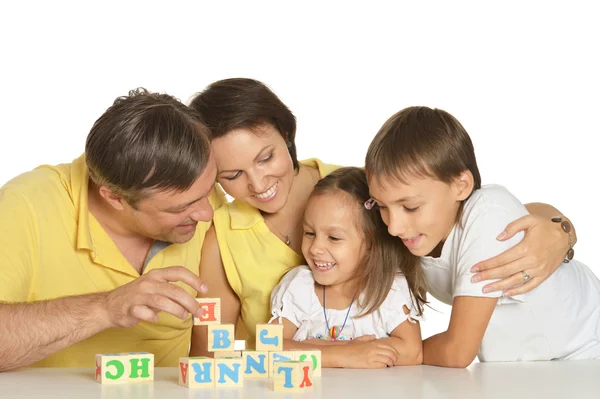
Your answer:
[179,298,321,391]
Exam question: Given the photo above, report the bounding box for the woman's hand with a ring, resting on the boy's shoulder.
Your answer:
[471,215,569,296]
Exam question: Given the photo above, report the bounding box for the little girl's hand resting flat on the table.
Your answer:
[339,339,398,369]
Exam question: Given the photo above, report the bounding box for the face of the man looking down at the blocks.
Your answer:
[126,155,217,244]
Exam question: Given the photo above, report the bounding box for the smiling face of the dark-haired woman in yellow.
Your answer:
[212,124,295,213]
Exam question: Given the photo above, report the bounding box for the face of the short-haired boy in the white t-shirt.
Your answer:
[369,176,470,256]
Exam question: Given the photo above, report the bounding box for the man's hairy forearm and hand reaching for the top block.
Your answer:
[0,266,202,371]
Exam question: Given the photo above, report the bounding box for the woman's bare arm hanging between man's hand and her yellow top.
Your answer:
[190,226,241,356]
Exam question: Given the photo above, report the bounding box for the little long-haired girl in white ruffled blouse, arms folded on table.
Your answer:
[271,168,424,368]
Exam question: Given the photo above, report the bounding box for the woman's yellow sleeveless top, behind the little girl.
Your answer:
[213,159,339,348]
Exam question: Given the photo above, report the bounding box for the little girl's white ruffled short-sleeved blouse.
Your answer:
[271,266,420,341]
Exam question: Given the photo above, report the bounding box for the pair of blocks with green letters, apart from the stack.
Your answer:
[96,352,154,384]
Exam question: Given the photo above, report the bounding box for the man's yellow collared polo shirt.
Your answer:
[0,156,225,367]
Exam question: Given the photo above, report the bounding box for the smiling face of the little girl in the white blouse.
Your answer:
[302,193,364,285]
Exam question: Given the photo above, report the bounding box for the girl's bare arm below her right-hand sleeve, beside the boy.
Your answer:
[378,305,423,366]
